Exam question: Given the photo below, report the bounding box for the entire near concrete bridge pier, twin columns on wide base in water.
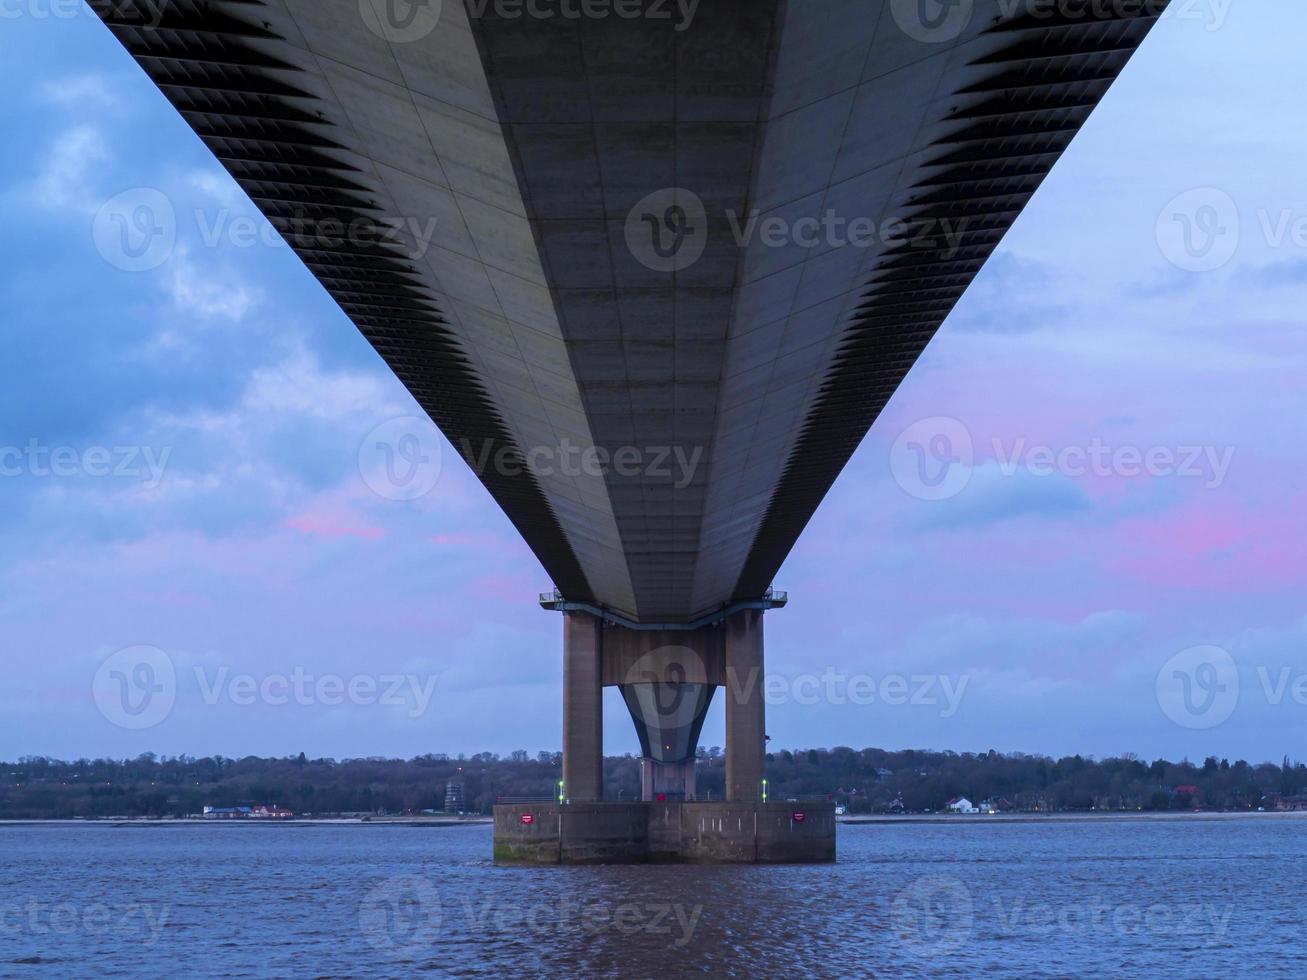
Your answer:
[494,593,835,864]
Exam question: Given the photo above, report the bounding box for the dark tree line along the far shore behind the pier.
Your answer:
[0,746,1307,819]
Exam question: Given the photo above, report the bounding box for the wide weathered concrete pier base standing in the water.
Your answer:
[494,802,835,865]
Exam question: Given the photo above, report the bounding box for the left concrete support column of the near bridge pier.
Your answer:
[563,613,604,804]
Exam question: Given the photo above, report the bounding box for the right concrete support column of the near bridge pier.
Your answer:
[723,609,767,802]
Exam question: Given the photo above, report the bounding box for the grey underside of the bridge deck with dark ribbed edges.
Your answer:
[93,0,1165,623]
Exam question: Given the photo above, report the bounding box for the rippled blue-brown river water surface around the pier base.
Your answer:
[0,817,1307,977]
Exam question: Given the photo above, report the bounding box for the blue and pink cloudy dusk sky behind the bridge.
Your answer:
[0,0,1307,762]
